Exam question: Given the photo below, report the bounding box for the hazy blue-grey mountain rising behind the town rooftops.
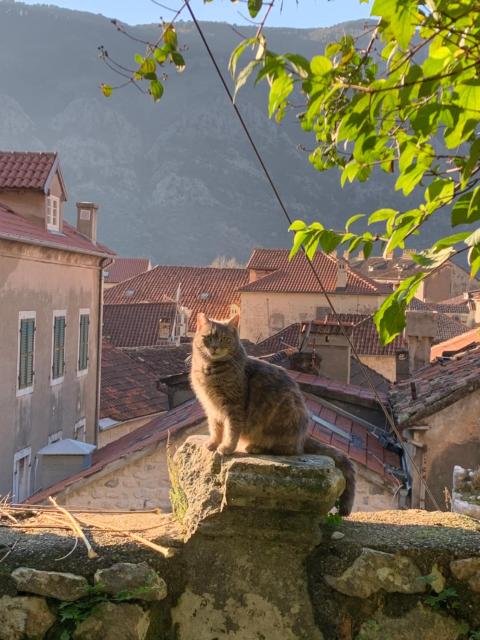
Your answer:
[0,1,452,264]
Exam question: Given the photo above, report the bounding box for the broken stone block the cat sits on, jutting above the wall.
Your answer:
[174,436,345,540]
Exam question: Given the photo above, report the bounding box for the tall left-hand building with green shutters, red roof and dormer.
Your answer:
[0,152,114,501]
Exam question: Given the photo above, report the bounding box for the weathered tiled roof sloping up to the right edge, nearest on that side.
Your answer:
[389,348,480,426]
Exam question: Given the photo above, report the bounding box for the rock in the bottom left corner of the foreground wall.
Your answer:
[0,596,55,640]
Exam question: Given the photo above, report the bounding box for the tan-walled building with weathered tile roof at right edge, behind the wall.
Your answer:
[389,347,480,509]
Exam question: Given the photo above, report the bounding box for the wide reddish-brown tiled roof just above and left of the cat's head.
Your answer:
[105,266,248,331]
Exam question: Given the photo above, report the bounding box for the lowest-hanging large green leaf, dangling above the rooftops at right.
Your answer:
[373,273,425,345]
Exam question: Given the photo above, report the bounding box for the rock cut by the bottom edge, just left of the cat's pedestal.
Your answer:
[73,602,150,640]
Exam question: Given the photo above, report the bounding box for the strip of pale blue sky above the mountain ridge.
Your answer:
[24,0,369,27]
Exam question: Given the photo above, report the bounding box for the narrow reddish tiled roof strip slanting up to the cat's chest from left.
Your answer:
[26,400,205,504]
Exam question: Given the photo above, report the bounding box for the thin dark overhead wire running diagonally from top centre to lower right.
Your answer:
[184,0,440,511]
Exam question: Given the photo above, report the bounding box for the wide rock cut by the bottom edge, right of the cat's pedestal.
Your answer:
[356,603,464,640]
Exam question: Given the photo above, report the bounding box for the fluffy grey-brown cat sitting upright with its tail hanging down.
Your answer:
[190,313,355,515]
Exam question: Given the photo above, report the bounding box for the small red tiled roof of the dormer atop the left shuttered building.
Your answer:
[0,151,57,191]
